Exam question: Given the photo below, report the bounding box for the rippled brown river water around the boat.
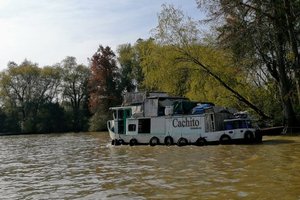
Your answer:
[0,133,300,199]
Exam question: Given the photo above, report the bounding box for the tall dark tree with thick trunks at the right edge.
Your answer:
[197,0,300,126]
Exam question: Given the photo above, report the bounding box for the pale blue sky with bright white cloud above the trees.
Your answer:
[0,0,202,71]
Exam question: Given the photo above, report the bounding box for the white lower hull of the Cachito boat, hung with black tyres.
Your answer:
[108,116,261,146]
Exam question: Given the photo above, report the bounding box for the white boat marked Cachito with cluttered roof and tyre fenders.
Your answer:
[107,93,262,146]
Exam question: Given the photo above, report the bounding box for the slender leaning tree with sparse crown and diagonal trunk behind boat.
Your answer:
[153,5,268,118]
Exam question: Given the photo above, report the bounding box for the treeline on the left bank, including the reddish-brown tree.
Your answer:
[0,45,141,133]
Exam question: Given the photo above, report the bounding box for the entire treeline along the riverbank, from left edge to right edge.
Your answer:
[0,0,300,132]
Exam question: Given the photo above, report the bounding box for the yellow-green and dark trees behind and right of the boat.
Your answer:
[114,0,300,126]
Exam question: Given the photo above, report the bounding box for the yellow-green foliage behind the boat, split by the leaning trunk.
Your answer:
[137,42,245,107]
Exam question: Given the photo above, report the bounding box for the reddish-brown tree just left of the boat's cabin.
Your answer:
[89,45,122,130]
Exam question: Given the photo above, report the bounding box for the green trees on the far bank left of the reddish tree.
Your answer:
[0,57,89,133]
